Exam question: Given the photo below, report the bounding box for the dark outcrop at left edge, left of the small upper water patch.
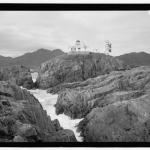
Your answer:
[0,65,34,89]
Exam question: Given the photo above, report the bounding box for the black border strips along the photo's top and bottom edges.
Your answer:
[0,3,150,147]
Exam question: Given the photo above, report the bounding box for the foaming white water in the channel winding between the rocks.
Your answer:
[29,73,83,142]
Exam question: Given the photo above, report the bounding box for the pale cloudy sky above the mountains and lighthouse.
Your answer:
[0,11,150,57]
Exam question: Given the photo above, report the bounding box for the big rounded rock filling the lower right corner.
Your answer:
[79,94,150,142]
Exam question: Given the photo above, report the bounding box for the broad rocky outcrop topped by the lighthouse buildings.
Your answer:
[37,53,127,89]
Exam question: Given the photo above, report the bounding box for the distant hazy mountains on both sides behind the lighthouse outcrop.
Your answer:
[0,48,150,69]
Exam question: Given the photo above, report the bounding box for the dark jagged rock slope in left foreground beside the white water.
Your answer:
[0,81,76,142]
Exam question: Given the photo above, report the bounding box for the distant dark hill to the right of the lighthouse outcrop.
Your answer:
[116,52,150,66]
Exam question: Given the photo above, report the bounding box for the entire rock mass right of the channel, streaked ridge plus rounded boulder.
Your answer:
[56,67,150,142]
